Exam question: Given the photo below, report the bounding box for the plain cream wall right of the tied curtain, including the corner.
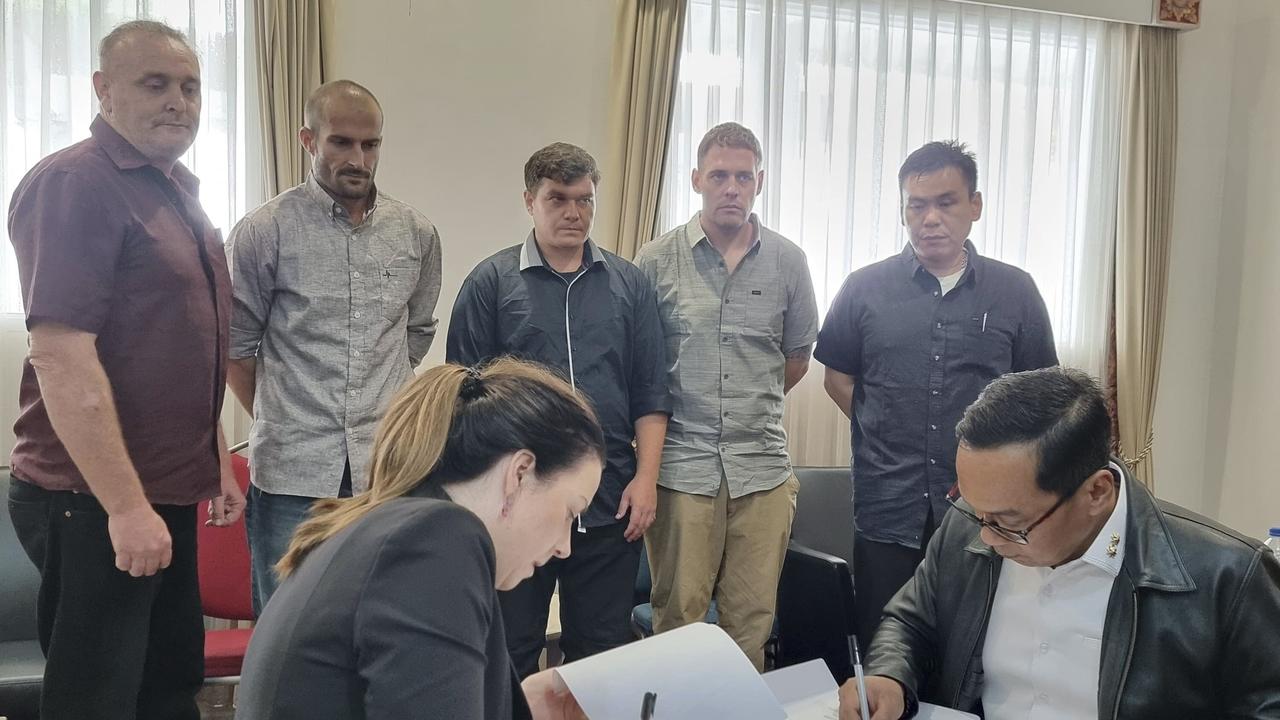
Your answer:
[1156,0,1280,536]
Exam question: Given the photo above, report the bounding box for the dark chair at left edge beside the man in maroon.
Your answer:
[0,473,45,720]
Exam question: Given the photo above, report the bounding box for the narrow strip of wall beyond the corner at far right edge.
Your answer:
[1206,0,1280,536]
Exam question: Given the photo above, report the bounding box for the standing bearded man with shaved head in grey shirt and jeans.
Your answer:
[227,81,440,611]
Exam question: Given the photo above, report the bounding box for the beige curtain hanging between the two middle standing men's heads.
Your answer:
[593,0,687,259]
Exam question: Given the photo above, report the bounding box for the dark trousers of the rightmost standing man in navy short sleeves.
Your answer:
[854,510,937,645]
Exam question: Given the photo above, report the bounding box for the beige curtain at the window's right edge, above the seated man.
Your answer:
[1115,27,1178,489]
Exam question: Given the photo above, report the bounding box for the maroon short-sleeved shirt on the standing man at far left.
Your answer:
[9,117,230,505]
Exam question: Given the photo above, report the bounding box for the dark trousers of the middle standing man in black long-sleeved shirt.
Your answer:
[498,520,640,678]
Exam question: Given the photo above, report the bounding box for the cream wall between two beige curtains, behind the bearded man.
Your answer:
[323,0,617,363]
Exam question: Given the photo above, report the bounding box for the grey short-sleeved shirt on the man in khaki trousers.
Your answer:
[636,213,818,497]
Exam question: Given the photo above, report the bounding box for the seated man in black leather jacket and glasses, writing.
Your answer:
[840,368,1280,720]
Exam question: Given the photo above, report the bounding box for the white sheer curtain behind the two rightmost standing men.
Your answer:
[662,0,1126,465]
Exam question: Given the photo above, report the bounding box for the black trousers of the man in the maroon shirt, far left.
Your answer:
[9,478,205,720]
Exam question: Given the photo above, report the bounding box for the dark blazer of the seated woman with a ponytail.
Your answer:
[236,491,530,720]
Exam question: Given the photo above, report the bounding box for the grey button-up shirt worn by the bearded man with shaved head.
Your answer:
[227,178,440,497]
